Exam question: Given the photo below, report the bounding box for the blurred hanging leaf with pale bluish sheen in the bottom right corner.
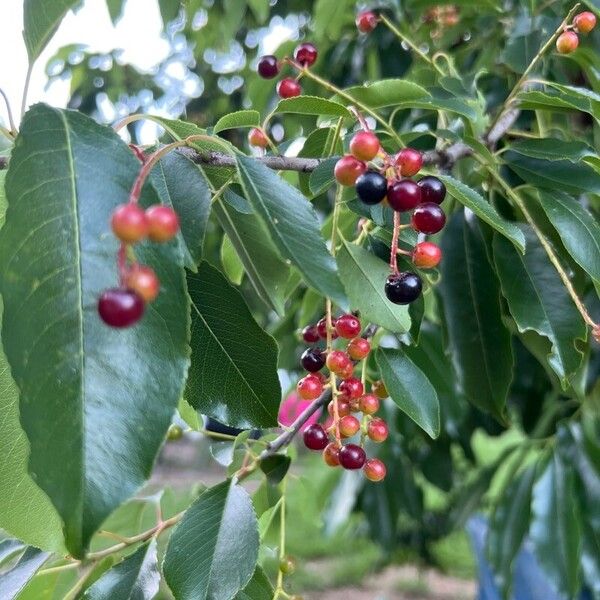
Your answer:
[529,452,581,597]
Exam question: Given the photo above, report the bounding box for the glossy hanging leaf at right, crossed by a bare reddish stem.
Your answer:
[493,226,587,385]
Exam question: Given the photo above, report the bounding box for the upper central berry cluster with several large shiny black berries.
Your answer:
[334,130,446,304]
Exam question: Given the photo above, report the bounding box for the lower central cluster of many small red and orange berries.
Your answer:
[297,314,388,481]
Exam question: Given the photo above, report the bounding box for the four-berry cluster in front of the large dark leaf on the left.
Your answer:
[98,201,179,327]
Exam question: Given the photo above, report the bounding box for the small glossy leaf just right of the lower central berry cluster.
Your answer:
[375,348,440,438]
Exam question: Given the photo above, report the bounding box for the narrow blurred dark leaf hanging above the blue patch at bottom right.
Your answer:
[486,465,536,594]
